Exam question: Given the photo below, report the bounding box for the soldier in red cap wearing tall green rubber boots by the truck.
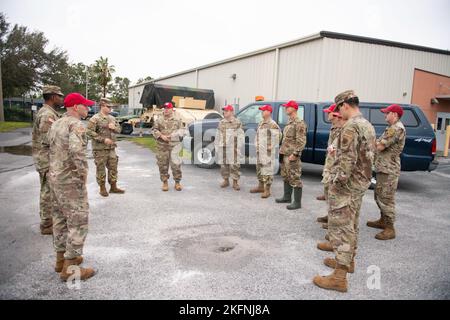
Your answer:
[275,100,307,210]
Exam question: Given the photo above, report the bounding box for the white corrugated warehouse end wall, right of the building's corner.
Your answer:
[317,38,450,103]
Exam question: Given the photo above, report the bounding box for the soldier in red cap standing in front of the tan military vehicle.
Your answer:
[153,102,186,191]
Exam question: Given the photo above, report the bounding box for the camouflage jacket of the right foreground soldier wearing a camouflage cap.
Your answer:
[330,114,376,192]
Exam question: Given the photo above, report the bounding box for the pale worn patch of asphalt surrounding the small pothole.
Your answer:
[172,234,264,271]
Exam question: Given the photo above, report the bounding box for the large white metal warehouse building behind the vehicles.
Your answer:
[129,31,450,121]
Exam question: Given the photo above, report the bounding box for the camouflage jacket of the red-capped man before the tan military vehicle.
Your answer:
[153,115,187,146]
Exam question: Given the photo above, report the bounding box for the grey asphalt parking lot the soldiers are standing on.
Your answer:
[0,129,450,299]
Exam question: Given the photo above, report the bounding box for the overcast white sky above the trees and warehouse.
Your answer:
[0,0,450,82]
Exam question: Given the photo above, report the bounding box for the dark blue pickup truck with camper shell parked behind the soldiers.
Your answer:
[183,101,438,171]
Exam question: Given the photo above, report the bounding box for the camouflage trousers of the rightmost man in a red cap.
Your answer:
[374,172,399,224]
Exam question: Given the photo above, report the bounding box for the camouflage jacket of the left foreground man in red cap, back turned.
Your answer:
[48,115,88,185]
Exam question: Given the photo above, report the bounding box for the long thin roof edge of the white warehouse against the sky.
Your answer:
[129,31,450,88]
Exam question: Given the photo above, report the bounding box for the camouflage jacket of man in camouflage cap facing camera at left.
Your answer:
[87,112,121,151]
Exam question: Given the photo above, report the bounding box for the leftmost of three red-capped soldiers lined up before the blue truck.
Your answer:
[214,105,244,191]
